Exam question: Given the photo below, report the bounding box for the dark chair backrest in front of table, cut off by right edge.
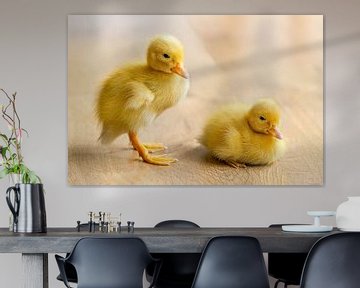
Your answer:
[300,232,360,288]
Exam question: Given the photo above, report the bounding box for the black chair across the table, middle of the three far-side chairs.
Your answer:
[146,220,201,288]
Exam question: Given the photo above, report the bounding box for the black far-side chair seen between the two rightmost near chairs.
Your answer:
[268,224,307,288]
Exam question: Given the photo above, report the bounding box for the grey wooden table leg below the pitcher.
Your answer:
[22,253,49,288]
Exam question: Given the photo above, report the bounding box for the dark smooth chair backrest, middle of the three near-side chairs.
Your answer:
[192,236,269,288]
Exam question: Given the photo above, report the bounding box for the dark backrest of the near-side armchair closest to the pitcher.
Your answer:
[67,238,153,288]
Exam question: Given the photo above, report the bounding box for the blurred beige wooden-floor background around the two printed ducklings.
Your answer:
[68,15,324,185]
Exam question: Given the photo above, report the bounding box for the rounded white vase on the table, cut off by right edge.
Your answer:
[336,196,360,231]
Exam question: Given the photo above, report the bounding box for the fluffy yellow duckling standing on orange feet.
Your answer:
[96,35,189,165]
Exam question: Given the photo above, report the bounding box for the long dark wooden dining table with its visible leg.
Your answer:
[0,227,339,288]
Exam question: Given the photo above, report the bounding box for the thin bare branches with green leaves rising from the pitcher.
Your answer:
[0,89,41,183]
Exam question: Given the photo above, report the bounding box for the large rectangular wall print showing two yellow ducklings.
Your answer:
[68,15,324,185]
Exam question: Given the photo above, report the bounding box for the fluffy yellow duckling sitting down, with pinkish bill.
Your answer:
[200,99,285,168]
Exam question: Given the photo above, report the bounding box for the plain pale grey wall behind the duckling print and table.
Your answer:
[0,0,360,287]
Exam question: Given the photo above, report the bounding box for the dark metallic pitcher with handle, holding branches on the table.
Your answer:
[6,184,47,233]
